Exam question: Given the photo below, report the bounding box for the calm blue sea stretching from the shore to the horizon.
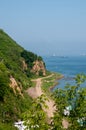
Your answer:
[43,56,86,90]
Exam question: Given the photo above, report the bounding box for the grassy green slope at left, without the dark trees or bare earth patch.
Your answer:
[0,30,39,130]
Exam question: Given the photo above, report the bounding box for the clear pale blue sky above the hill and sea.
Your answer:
[0,0,86,56]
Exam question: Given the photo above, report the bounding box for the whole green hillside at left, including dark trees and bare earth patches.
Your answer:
[0,29,45,130]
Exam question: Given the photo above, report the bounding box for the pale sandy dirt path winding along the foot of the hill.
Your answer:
[27,74,56,118]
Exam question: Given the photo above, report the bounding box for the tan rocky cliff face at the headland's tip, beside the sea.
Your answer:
[31,60,46,76]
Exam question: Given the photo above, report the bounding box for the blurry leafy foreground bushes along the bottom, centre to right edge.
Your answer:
[23,75,86,130]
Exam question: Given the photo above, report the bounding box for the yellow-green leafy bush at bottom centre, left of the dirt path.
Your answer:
[23,95,49,130]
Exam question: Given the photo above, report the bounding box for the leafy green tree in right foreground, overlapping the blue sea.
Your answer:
[53,75,86,130]
